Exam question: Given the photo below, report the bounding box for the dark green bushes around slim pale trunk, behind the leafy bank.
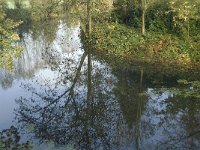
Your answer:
[112,0,200,38]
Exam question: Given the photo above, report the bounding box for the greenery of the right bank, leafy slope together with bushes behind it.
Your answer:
[85,0,200,68]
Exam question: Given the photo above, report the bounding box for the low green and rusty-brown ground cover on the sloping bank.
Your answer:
[85,23,197,67]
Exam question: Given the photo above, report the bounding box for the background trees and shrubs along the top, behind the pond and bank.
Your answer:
[0,0,200,69]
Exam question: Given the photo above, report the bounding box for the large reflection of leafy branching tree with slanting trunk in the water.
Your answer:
[17,48,120,149]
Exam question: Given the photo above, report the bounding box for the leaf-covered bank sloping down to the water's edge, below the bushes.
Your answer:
[81,23,200,77]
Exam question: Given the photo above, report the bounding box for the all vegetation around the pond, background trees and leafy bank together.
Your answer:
[0,0,200,68]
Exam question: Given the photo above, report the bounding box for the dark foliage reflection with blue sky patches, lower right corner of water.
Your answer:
[144,86,200,149]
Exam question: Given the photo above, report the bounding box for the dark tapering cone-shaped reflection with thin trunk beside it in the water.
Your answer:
[115,69,148,149]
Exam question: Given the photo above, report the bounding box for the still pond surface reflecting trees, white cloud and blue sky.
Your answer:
[0,21,200,150]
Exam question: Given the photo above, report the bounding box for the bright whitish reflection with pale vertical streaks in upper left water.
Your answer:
[0,21,81,89]
